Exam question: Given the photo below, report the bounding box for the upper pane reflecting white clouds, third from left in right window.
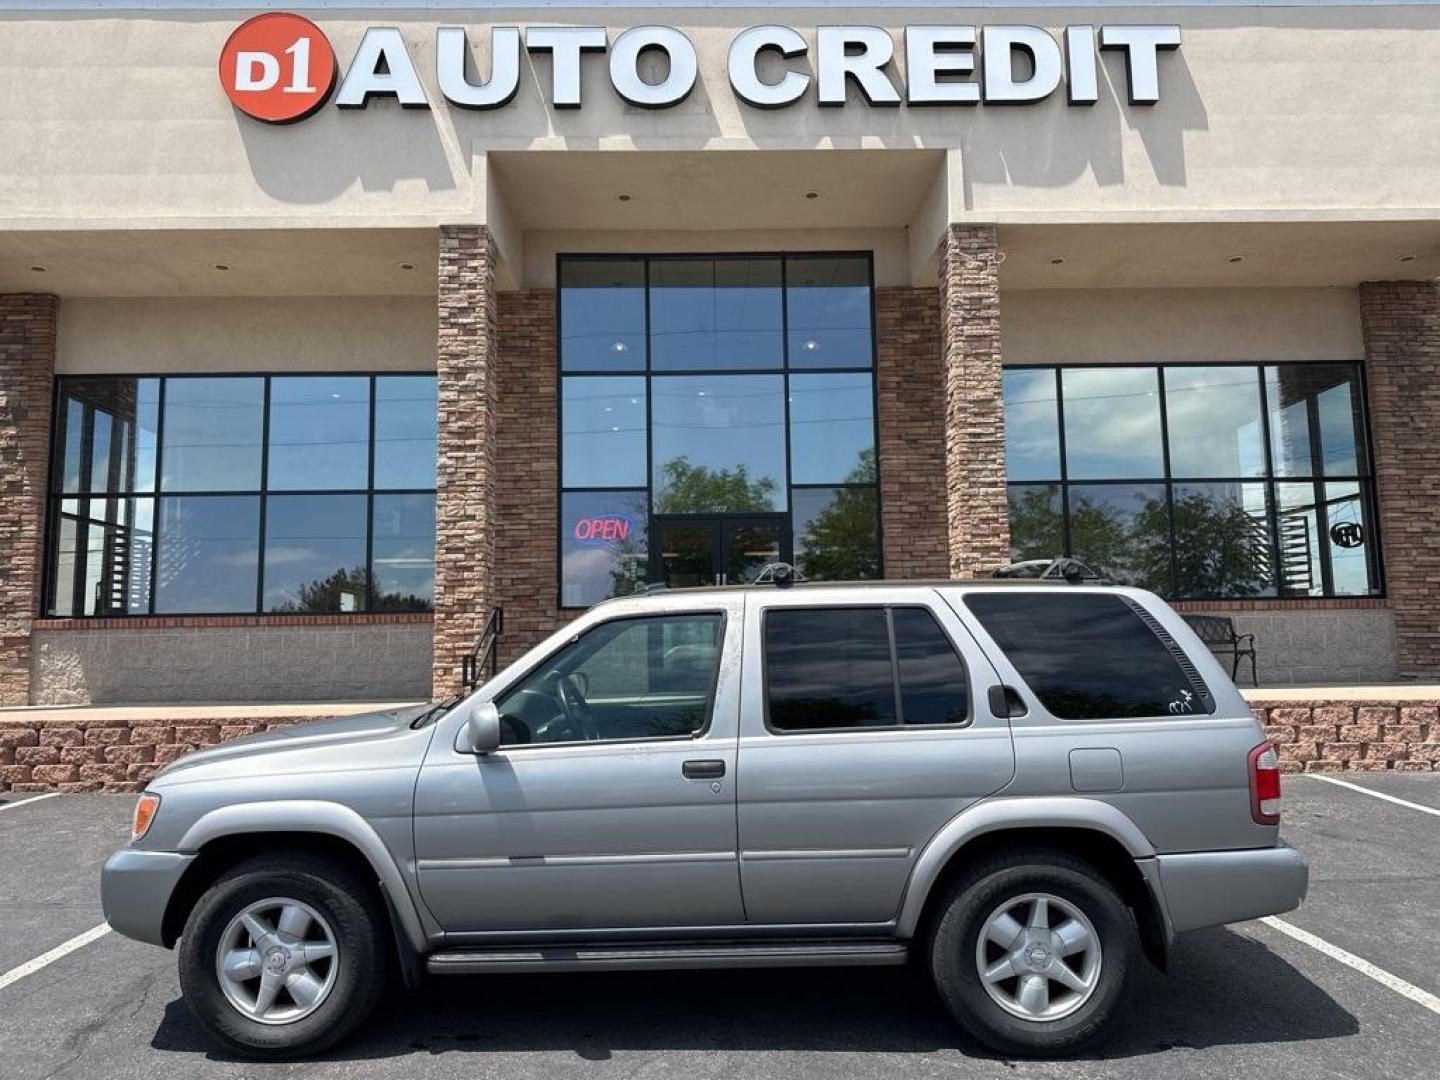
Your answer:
[1169,367,1264,477]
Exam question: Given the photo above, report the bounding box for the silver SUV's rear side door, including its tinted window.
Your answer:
[737,588,1015,924]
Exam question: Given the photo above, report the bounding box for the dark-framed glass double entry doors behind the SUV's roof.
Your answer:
[649,514,791,589]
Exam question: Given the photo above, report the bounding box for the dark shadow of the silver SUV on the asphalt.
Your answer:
[151,929,1359,1061]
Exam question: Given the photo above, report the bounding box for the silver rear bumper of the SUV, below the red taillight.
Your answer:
[1155,844,1310,932]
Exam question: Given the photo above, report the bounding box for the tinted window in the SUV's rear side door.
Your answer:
[765,606,969,732]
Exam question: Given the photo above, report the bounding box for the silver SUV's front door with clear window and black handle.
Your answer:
[415,595,744,936]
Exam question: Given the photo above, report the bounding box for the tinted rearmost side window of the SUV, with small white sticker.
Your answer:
[965,590,1214,720]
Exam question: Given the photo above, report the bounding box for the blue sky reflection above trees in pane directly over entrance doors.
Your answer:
[651,374,785,508]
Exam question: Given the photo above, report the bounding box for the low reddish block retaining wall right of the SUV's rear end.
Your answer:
[1251,700,1440,772]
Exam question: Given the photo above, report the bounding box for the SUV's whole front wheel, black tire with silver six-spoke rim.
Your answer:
[180,852,387,1057]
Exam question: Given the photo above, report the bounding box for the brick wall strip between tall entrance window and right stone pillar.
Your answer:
[876,288,950,577]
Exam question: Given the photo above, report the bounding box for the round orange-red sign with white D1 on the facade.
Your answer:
[220,12,337,124]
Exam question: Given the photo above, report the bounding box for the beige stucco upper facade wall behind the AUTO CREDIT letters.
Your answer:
[0,4,1440,228]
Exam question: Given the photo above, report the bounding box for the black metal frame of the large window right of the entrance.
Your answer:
[1002,360,1388,603]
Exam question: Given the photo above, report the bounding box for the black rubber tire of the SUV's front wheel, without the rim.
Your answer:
[179,851,389,1060]
